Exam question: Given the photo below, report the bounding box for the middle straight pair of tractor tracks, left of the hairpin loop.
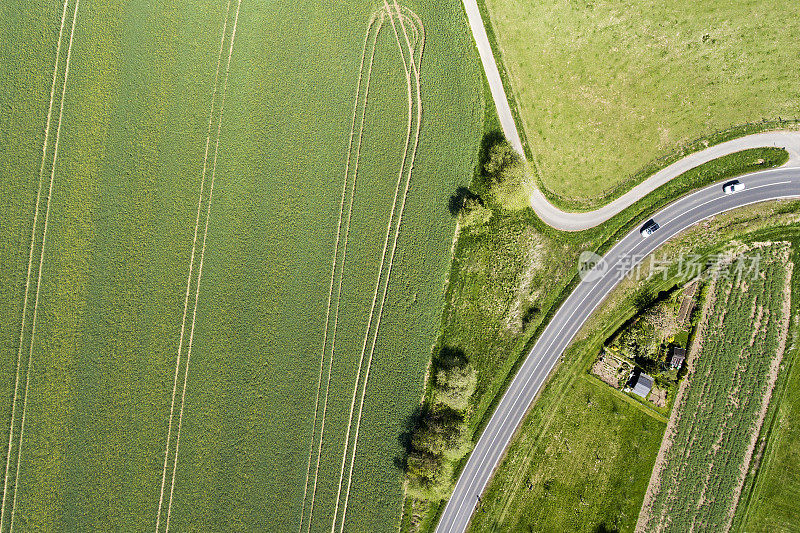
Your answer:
[156,0,242,532]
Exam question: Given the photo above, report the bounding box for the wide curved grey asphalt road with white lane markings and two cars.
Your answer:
[436,168,800,533]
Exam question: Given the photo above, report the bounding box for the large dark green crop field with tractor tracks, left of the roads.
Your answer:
[0,0,484,531]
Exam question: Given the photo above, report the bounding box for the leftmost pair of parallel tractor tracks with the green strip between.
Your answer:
[0,0,80,532]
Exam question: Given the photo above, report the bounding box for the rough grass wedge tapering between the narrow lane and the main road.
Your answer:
[468,144,788,444]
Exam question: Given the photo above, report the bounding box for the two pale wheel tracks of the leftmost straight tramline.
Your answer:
[0,0,80,532]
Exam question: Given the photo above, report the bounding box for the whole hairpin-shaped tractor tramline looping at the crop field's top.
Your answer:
[299,1,425,532]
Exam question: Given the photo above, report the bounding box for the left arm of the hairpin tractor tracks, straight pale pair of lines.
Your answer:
[299,11,383,532]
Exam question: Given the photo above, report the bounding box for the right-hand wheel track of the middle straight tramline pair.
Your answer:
[164,0,242,533]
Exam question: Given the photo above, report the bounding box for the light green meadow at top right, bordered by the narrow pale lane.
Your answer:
[482,0,800,208]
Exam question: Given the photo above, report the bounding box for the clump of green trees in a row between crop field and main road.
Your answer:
[405,348,477,501]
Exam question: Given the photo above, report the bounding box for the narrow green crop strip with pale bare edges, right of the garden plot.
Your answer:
[636,243,793,531]
